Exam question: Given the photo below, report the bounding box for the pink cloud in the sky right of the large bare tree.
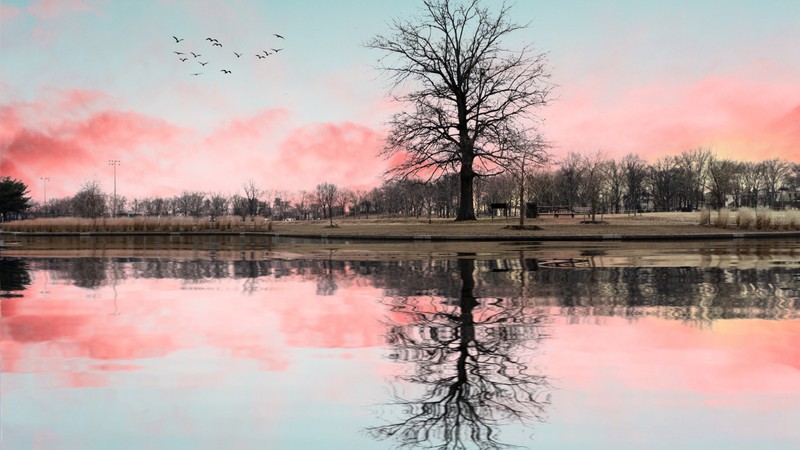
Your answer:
[543,76,800,161]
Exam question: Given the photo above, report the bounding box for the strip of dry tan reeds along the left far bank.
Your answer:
[3,216,272,233]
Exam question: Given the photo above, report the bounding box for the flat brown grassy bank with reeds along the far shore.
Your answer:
[2,211,800,240]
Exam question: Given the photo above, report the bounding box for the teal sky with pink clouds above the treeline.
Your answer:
[0,0,800,197]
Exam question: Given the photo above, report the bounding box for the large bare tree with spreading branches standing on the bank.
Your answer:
[366,0,551,220]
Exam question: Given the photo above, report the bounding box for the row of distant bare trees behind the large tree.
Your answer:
[21,148,800,220]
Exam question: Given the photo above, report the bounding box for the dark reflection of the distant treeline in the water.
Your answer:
[26,258,800,319]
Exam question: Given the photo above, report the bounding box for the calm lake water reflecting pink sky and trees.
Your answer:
[0,241,800,450]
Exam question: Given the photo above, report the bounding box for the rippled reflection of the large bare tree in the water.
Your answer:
[367,258,549,450]
